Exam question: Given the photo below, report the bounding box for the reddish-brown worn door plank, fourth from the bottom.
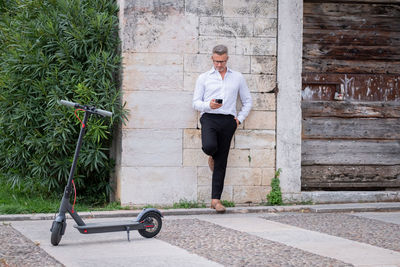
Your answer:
[301,101,400,118]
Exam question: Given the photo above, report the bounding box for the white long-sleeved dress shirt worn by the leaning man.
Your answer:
[192,67,252,123]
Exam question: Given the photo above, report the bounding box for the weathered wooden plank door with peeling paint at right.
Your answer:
[301,0,400,190]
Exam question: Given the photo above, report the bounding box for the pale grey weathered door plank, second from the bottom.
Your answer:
[301,140,400,165]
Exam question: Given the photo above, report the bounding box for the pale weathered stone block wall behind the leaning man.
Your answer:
[116,0,277,205]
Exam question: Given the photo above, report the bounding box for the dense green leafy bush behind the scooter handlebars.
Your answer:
[0,0,125,200]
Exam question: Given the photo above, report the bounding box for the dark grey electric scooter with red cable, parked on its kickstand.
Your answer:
[50,100,163,246]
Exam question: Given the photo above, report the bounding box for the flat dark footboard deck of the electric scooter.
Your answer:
[74,221,146,234]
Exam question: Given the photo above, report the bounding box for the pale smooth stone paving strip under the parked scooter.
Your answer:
[11,218,221,267]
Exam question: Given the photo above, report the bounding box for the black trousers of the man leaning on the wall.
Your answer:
[200,113,237,199]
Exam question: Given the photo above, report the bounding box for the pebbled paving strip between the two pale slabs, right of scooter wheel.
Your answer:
[159,219,351,266]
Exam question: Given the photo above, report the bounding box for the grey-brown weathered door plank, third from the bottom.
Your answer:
[303,117,400,140]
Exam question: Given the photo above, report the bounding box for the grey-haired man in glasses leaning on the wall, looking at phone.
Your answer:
[193,45,252,212]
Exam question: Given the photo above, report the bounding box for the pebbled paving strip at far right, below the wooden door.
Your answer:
[264,213,400,251]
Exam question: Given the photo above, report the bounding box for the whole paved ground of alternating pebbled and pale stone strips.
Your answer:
[0,203,400,266]
